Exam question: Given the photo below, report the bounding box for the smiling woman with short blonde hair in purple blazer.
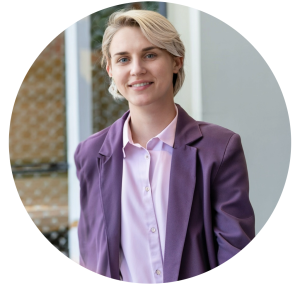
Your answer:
[74,10,255,283]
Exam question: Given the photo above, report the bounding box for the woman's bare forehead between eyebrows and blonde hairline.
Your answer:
[109,26,154,56]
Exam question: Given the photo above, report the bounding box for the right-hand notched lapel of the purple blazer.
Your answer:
[163,105,202,282]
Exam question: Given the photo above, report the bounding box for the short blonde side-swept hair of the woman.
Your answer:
[101,9,185,96]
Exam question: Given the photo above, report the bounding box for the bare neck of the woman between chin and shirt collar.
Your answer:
[129,100,176,148]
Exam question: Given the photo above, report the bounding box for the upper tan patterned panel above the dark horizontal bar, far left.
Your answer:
[9,33,66,165]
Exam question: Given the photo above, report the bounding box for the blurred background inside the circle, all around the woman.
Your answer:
[9,2,291,262]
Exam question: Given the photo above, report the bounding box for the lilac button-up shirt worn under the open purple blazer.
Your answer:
[120,106,178,283]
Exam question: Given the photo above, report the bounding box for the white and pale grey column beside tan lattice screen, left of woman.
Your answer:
[65,17,92,262]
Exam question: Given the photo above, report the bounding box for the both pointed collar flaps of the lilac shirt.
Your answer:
[122,105,178,157]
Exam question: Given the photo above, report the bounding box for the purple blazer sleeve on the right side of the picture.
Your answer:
[212,134,255,264]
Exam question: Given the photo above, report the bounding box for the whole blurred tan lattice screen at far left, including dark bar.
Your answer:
[9,33,68,254]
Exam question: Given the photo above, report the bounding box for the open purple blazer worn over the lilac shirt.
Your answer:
[74,104,255,282]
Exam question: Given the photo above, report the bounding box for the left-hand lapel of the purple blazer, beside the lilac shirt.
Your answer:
[98,113,128,280]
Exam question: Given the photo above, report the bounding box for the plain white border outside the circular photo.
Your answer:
[0,0,300,300]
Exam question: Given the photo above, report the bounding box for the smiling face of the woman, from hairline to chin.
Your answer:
[106,27,183,107]
